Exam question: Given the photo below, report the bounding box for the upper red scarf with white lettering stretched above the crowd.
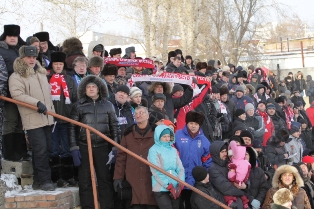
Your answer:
[104,57,155,68]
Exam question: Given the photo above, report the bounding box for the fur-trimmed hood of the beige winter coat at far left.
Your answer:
[13,57,47,78]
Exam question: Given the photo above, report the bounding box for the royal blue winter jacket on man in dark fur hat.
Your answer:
[175,125,212,188]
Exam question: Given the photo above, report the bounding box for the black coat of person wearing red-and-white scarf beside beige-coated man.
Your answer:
[47,70,77,123]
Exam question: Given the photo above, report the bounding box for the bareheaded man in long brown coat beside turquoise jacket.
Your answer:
[113,106,158,209]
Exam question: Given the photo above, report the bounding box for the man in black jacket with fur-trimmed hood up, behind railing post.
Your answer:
[68,76,120,208]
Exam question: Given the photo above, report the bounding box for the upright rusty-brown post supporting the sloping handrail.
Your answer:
[86,129,98,209]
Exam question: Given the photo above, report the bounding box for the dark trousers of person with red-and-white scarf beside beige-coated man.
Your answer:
[51,123,72,158]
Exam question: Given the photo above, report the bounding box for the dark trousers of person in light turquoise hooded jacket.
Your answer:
[154,192,180,209]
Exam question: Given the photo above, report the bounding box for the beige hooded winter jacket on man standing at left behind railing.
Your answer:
[9,57,55,130]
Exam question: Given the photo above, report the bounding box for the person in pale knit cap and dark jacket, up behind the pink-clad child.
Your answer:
[245,103,265,141]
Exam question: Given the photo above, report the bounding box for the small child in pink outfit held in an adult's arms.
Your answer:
[228,141,251,186]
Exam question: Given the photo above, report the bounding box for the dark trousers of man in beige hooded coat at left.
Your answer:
[27,126,51,184]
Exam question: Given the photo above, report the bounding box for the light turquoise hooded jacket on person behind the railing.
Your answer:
[147,125,185,192]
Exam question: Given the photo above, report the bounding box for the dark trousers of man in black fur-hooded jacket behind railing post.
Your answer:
[78,145,114,209]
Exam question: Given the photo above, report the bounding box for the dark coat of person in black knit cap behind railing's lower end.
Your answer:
[190,182,226,209]
